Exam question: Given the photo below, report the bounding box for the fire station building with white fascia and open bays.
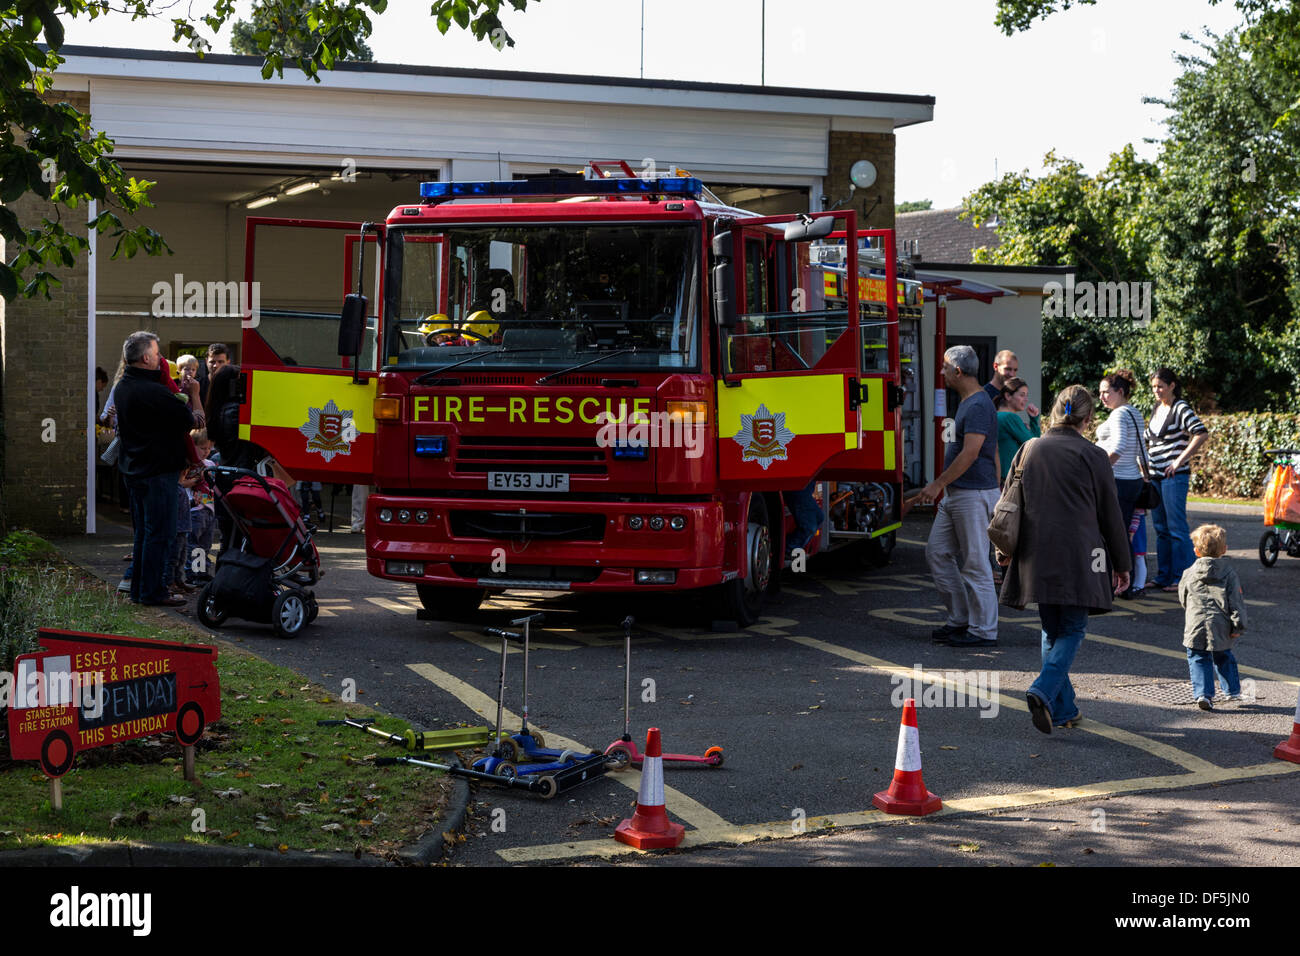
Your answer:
[0,47,1040,533]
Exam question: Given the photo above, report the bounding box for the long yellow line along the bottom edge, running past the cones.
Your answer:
[497,761,1300,862]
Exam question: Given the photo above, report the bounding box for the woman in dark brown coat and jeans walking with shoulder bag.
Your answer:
[997,385,1132,734]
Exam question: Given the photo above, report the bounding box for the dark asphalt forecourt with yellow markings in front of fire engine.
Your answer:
[59,505,1300,865]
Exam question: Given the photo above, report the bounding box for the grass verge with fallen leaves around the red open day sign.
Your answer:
[0,535,450,857]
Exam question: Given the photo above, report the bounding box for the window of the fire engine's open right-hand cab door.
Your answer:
[727,234,849,372]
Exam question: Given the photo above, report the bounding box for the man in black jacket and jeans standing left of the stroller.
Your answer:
[114,332,195,607]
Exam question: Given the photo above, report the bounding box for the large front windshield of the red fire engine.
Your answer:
[385,222,701,371]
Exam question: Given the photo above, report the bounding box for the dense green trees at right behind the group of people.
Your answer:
[966,0,1300,410]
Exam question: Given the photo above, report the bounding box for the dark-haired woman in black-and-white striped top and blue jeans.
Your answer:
[1147,368,1210,591]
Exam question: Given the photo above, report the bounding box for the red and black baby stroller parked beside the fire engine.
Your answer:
[198,466,322,637]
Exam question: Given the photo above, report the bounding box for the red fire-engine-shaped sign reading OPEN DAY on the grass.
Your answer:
[9,628,221,777]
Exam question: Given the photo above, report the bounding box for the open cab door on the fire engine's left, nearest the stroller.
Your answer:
[239,216,384,484]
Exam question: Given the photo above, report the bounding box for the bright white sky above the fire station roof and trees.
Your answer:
[66,0,1240,208]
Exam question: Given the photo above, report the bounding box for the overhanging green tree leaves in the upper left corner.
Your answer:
[0,0,540,299]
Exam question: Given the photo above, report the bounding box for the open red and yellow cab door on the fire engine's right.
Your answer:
[714,212,859,490]
